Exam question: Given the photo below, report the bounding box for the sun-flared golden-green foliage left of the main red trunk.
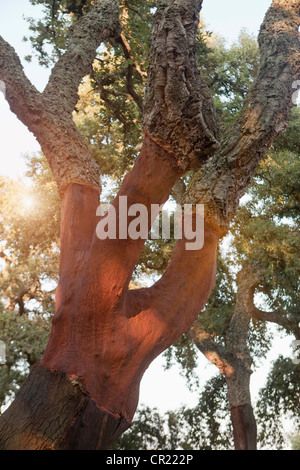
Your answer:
[0,155,60,406]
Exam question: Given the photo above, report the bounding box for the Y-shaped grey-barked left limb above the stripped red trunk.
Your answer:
[0,0,120,194]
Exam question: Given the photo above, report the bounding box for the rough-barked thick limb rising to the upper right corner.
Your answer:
[185,0,300,233]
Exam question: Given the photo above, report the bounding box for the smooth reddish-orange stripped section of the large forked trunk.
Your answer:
[0,139,218,448]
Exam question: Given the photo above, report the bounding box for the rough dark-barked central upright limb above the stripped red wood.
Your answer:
[143,0,219,172]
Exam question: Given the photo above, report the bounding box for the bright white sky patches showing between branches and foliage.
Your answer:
[0,0,296,434]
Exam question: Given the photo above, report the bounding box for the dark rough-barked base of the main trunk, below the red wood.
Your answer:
[0,366,129,450]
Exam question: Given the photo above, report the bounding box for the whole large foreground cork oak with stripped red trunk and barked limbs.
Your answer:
[0,0,299,450]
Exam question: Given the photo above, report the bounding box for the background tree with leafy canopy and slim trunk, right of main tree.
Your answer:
[158,109,300,448]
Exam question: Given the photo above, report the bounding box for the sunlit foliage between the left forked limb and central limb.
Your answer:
[74,0,155,182]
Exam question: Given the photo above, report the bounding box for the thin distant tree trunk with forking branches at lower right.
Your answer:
[189,263,299,450]
